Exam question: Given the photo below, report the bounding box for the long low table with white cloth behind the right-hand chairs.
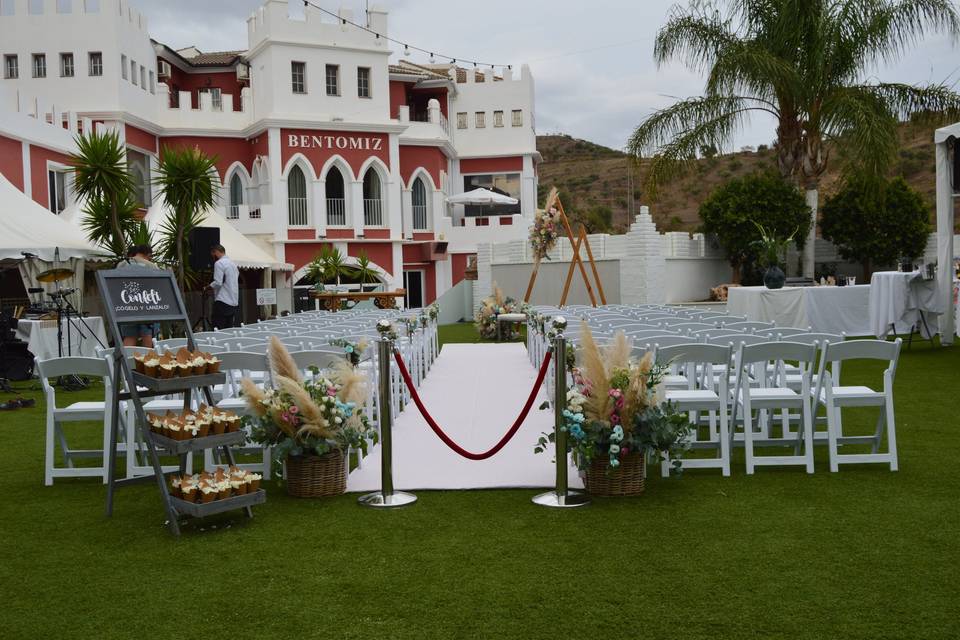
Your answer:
[727,284,892,336]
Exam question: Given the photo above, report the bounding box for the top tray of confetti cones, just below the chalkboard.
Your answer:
[133,347,226,391]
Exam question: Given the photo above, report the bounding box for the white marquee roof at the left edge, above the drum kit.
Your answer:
[0,174,103,262]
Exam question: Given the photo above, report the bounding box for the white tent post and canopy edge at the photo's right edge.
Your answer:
[934,122,960,344]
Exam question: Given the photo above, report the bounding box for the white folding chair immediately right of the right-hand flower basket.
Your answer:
[656,343,731,477]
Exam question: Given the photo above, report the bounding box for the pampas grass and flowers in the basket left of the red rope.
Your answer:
[241,338,377,474]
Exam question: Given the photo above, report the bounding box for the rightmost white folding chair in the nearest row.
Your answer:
[816,338,902,471]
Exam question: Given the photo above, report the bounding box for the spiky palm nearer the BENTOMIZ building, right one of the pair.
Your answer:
[155,147,220,289]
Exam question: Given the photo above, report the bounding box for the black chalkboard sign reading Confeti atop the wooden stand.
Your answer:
[97,267,186,324]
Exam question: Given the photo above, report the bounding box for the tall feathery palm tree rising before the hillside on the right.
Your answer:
[627,0,960,276]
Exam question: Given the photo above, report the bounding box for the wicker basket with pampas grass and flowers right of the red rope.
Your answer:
[534,323,693,496]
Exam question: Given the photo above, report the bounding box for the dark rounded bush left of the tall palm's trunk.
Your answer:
[700,171,810,279]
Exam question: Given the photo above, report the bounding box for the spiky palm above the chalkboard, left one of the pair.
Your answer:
[70,131,139,259]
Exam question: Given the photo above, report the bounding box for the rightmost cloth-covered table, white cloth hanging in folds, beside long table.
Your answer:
[870,271,944,339]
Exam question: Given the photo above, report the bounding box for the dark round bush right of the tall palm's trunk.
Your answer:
[820,177,930,279]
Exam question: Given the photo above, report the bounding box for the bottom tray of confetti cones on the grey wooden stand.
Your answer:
[169,467,267,518]
